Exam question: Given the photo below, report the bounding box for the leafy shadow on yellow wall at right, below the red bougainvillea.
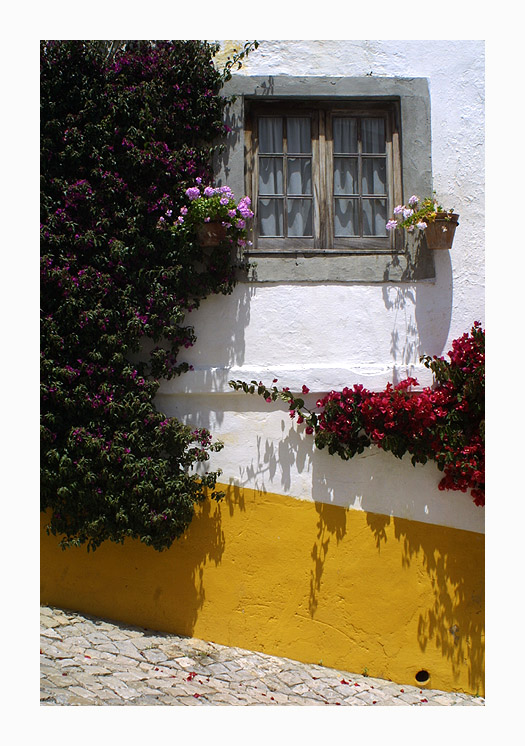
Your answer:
[367,514,484,693]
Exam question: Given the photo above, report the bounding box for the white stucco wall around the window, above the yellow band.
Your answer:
[158,40,484,531]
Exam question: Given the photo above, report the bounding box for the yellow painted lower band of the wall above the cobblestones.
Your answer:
[41,487,484,695]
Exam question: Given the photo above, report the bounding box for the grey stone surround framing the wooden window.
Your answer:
[216,75,435,283]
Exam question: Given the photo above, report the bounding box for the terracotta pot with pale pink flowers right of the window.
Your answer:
[386,194,459,249]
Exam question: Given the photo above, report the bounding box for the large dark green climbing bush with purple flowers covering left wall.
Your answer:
[41,40,256,550]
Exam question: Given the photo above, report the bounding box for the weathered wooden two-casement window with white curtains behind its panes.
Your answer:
[246,102,402,253]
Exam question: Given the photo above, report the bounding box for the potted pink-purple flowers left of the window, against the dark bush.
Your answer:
[173,179,253,249]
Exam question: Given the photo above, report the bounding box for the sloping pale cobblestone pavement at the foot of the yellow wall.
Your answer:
[40,606,485,707]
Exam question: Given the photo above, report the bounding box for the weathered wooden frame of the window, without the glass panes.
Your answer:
[245,99,403,255]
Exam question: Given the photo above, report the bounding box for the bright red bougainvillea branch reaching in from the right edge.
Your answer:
[230,322,485,506]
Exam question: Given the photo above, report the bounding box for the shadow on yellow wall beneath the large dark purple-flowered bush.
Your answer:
[40,495,227,635]
